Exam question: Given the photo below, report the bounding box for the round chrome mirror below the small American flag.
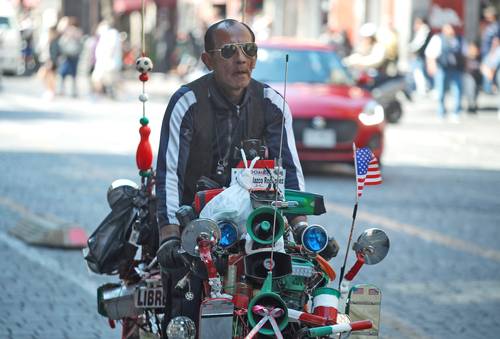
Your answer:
[352,228,390,265]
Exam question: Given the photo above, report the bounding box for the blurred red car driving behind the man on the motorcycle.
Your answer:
[252,38,385,163]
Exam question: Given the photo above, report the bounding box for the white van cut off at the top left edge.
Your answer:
[0,0,24,74]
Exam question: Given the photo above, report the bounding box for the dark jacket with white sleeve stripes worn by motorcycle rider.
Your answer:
[156,73,304,226]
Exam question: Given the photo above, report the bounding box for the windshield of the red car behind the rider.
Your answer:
[252,47,354,85]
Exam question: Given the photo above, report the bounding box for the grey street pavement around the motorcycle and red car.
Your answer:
[0,76,500,338]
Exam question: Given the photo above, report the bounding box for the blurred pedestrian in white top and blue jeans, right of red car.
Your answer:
[425,24,465,123]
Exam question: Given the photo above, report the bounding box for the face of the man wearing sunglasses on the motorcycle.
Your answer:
[204,24,257,92]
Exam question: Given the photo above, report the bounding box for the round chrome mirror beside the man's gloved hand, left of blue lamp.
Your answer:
[181,218,220,257]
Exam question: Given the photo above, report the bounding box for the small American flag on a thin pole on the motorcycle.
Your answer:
[356,147,382,198]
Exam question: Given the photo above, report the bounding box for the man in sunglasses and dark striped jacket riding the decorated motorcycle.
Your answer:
[156,19,305,334]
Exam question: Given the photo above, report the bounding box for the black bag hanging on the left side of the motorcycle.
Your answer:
[85,191,138,274]
